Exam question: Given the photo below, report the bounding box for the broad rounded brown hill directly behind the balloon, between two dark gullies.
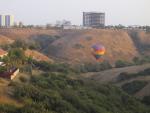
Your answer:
[47,29,139,63]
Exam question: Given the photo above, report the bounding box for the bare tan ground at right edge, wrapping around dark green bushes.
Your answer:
[82,64,150,99]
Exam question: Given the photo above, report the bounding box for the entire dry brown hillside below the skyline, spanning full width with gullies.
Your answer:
[0,28,150,63]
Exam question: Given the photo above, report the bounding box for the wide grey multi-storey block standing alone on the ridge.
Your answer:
[83,12,105,27]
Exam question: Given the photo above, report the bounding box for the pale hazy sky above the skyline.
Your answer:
[0,0,150,25]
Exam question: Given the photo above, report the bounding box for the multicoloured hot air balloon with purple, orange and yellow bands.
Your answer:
[92,44,106,61]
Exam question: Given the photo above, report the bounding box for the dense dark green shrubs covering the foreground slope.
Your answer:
[0,73,149,113]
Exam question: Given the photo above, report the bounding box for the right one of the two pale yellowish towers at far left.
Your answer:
[5,15,14,27]
